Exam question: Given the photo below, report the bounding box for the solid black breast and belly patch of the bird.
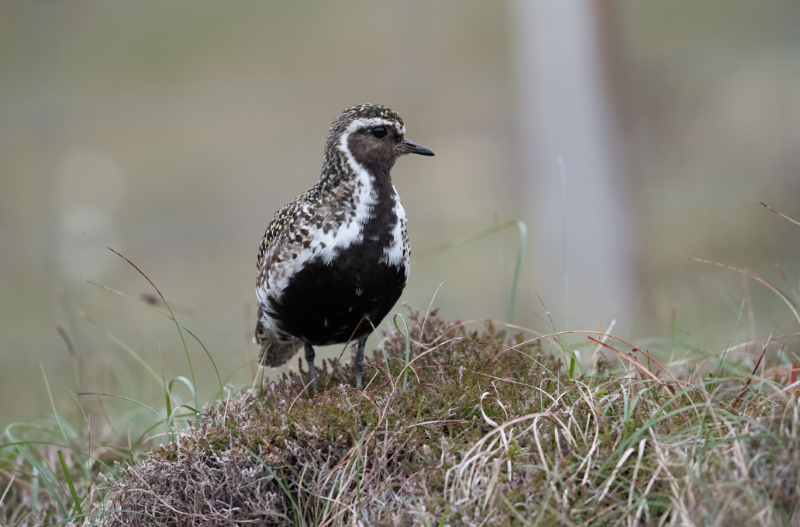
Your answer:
[268,173,406,345]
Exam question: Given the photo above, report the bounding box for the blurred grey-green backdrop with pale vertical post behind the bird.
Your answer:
[0,0,800,423]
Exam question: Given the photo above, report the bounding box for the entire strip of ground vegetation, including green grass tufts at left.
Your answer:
[0,209,800,527]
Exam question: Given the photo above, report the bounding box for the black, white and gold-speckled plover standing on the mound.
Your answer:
[254,104,434,393]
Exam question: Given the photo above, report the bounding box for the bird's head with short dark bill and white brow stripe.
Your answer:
[326,104,434,171]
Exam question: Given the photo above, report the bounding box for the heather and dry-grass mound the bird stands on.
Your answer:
[59,314,800,526]
